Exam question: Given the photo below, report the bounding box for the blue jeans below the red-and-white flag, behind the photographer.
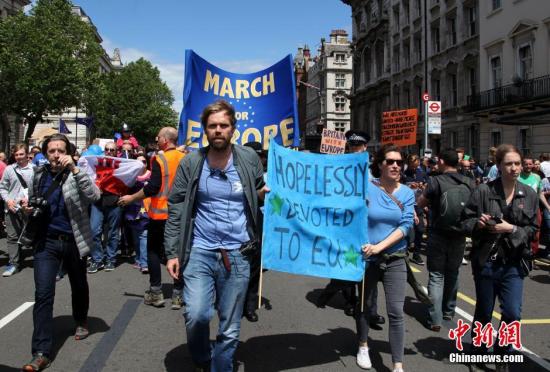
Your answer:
[90,204,122,264]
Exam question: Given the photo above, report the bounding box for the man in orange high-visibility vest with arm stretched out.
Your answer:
[118,127,185,310]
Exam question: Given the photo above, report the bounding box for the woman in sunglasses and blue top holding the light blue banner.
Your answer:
[356,144,415,372]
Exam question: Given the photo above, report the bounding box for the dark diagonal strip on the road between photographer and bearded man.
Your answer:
[80,300,143,372]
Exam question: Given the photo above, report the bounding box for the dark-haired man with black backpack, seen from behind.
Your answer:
[417,149,475,332]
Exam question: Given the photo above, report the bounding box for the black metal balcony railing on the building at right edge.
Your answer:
[468,75,550,111]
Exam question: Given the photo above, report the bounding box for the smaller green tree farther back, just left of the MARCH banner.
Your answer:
[94,58,177,144]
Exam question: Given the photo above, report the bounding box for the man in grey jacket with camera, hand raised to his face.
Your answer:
[21,134,100,371]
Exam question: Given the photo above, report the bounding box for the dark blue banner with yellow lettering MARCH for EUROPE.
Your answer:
[178,50,300,149]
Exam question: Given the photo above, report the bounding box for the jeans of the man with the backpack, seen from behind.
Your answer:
[427,231,466,326]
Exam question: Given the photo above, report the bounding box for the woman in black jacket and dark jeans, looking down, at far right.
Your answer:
[463,144,538,371]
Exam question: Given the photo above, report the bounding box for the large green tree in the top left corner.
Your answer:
[0,0,104,139]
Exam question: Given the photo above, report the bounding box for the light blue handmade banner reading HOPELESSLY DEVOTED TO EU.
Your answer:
[262,141,369,281]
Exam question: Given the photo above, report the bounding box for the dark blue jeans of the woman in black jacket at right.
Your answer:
[472,259,523,354]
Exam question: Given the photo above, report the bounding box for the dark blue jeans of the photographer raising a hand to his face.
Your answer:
[32,237,90,356]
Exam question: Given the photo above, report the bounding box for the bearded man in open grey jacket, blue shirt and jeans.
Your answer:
[165,101,267,372]
